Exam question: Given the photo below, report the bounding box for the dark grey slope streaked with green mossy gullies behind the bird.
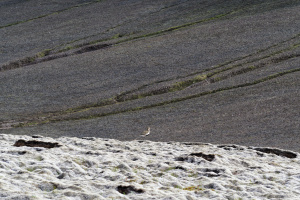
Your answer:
[0,0,300,151]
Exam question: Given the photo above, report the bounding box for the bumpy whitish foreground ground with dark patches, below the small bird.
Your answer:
[0,134,300,200]
